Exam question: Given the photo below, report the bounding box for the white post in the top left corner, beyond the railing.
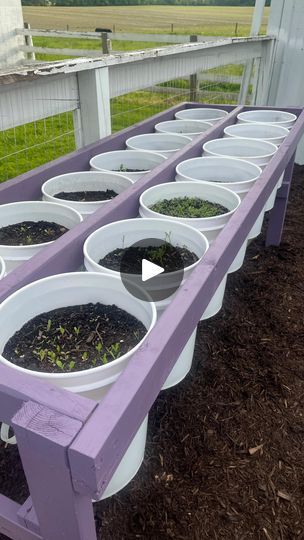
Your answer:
[0,0,24,67]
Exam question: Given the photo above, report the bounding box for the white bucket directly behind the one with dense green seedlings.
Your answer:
[175,156,265,253]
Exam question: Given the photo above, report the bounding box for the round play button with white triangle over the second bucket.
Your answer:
[120,238,184,302]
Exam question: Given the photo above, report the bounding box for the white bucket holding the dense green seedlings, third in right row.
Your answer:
[139,182,244,319]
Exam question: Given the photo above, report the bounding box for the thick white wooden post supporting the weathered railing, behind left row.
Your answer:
[74,67,111,147]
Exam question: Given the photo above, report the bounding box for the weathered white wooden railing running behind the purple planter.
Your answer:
[0,36,274,179]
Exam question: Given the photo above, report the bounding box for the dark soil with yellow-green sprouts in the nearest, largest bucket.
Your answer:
[3,303,147,373]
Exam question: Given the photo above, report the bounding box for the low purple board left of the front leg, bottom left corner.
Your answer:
[0,494,43,540]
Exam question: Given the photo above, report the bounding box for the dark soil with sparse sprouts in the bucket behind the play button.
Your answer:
[99,243,198,274]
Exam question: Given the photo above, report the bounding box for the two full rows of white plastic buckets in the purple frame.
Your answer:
[0,108,296,498]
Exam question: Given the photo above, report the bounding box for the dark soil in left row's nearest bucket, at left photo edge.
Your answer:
[0,221,68,246]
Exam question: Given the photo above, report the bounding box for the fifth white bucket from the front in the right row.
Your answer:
[203,137,278,169]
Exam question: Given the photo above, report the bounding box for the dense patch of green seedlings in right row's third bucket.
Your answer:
[150,197,229,218]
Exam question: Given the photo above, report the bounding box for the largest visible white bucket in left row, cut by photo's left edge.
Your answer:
[0,201,82,273]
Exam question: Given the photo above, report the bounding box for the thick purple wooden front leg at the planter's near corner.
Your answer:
[12,401,96,540]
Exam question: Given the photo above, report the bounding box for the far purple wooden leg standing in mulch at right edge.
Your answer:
[266,153,296,246]
